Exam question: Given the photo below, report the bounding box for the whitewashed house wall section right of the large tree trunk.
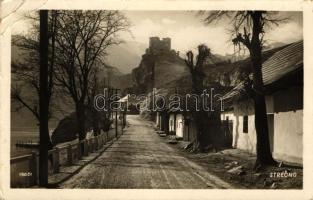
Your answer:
[273,87,303,163]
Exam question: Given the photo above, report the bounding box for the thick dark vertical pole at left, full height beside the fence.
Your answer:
[39,10,49,187]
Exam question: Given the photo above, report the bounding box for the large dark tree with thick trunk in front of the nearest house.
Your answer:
[204,11,287,168]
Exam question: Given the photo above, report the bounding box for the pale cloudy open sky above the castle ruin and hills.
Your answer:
[119,11,303,55]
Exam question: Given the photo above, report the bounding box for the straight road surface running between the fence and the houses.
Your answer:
[60,115,231,189]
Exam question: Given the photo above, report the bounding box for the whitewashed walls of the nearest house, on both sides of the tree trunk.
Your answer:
[227,88,303,163]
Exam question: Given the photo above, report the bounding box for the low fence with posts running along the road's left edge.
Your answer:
[10,132,115,188]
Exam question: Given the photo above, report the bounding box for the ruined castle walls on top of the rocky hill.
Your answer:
[146,37,178,55]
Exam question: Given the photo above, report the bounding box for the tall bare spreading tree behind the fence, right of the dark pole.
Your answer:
[55,11,129,148]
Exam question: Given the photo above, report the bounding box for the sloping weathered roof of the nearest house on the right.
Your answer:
[223,40,303,99]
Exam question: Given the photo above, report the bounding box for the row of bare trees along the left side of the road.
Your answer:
[11,10,130,186]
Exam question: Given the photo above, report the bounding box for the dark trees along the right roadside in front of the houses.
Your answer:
[186,11,287,168]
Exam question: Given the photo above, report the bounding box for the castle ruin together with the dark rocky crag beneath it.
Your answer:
[132,37,185,94]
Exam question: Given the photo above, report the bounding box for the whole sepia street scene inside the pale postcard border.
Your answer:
[10,10,304,190]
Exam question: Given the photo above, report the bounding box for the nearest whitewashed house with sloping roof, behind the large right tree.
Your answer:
[221,41,303,164]
